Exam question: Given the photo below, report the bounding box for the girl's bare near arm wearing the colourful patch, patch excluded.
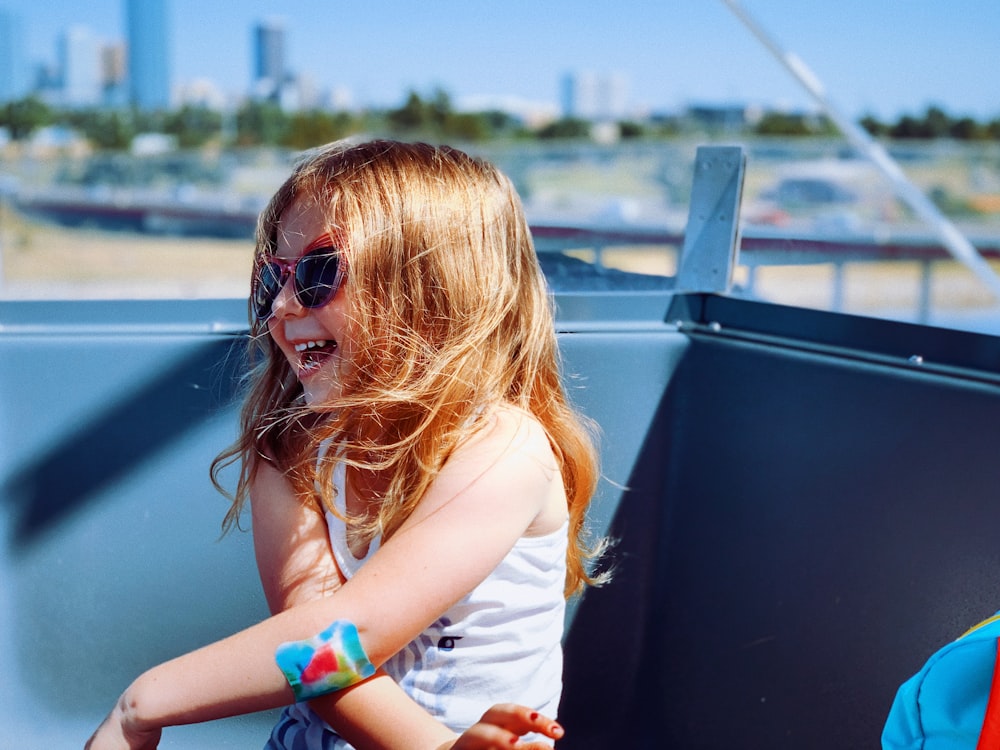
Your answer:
[87,413,561,747]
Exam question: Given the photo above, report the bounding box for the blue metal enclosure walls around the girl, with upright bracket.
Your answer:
[0,147,1000,750]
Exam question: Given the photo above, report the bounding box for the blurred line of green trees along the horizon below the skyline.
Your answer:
[7,93,1000,150]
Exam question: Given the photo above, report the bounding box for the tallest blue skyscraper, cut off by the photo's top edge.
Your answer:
[125,0,170,110]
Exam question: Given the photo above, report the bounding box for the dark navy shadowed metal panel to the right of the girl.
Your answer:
[564,299,1000,748]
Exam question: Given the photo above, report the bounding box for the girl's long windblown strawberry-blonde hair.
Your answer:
[212,141,598,595]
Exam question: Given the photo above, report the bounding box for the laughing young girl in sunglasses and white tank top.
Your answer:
[88,142,597,750]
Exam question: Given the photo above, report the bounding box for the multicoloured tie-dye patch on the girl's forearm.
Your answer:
[274,620,375,702]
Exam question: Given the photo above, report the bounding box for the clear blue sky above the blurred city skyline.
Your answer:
[7,0,1000,119]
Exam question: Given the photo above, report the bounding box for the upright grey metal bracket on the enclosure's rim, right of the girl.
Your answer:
[676,146,746,292]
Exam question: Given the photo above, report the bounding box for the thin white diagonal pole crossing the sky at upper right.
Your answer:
[722,0,1000,299]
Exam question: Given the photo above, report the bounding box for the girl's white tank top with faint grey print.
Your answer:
[326,463,569,731]
